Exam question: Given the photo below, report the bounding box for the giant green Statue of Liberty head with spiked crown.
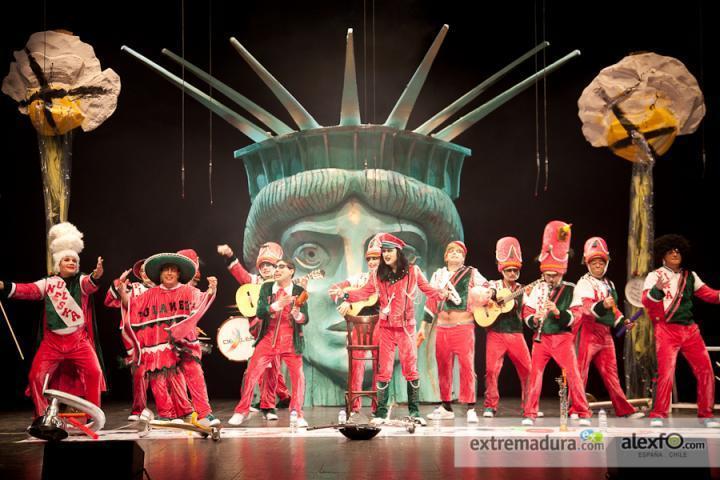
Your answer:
[123,25,579,405]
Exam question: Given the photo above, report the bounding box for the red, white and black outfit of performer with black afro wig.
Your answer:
[642,267,720,418]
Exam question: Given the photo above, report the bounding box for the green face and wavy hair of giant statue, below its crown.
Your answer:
[244,155,462,405]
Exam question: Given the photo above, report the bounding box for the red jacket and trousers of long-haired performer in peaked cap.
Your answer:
[347,265,440,382]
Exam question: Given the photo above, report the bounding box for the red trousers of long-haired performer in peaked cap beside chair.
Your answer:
[377,325,419,382]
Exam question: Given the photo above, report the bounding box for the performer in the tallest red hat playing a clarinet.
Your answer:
[522,220,592,426]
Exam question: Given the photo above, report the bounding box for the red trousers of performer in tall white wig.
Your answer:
[28,328,103,416]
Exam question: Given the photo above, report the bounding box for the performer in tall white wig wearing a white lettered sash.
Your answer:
[0,222,105,416]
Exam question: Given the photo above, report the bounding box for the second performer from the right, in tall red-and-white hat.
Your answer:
[570,237,645,418]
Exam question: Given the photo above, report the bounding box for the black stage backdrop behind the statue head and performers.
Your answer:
[0,0,720,408]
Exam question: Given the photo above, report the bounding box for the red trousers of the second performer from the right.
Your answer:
[570,323,635,417]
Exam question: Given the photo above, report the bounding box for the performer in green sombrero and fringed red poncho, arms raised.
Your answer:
[118,253,220,426]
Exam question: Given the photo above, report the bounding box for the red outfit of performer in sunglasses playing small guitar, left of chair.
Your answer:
[235,282,308,417]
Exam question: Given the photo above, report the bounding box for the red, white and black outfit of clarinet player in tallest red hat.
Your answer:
[523,282,591,418]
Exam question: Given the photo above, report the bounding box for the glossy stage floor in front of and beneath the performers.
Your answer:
[0,399,720,480]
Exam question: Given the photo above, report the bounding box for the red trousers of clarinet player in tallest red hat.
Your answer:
[524,333,591,418]
